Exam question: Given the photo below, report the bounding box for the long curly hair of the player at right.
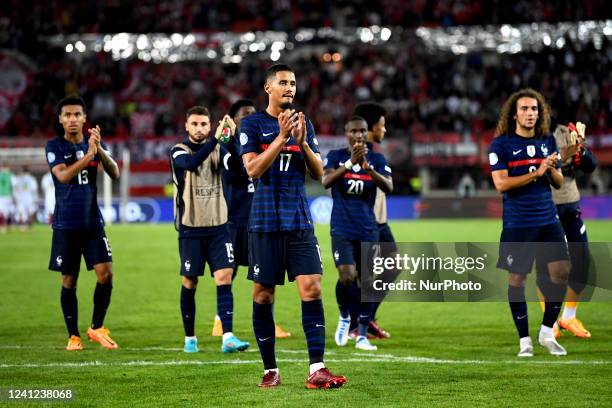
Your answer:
[495,88,550,137]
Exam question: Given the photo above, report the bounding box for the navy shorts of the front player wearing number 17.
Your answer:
[247,230,323,286]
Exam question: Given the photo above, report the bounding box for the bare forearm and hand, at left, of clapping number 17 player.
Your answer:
[242,109,297,179]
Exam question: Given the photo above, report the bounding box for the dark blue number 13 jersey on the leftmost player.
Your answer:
[45,136,110,230]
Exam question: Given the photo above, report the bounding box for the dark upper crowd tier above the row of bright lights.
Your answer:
[0,0,611,42]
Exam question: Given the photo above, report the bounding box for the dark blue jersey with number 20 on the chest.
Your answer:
[323,148,391,242]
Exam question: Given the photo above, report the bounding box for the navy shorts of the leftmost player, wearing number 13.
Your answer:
[49,228,113,276]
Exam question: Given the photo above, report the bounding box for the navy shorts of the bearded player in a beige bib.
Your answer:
[179,230,234,277]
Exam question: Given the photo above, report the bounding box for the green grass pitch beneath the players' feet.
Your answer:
[0,220,612,407]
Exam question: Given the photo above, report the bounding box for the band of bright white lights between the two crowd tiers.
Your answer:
[41,20,612,64]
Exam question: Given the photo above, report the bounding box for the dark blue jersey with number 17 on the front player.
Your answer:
[239,111,319,232]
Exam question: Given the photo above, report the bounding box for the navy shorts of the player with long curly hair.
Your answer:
[497,221,569,275]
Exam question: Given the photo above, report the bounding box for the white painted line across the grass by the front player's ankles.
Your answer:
[0,355,612,369]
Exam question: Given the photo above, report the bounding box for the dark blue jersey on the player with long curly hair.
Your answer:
[489,134,558,228]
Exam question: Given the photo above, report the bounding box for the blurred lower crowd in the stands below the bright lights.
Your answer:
[0,33,612,138]
